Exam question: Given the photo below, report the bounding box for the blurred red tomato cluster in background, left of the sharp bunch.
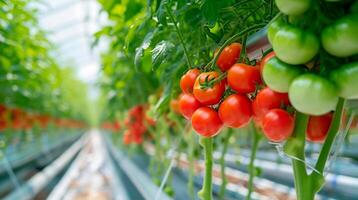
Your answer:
[123,105,156,145]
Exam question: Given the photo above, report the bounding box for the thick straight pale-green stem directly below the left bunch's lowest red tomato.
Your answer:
[198,137,213,200]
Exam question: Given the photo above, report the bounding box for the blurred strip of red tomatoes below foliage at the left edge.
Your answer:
[0,104,86,131]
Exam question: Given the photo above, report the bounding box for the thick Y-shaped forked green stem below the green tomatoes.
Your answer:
[285,98,345,200]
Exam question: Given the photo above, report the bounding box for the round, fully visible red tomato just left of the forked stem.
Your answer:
[262,109,295,142]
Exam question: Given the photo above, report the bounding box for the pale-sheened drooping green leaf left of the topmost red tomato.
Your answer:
[152,41,174,71]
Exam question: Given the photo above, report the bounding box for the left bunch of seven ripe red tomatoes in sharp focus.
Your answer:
[178,43,262,137]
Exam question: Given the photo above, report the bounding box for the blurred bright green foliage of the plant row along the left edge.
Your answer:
[0,0,88,119]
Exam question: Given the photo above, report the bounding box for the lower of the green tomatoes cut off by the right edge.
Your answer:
[330,62,358,99]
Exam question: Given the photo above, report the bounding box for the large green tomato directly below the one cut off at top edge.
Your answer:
[272,25,319,65]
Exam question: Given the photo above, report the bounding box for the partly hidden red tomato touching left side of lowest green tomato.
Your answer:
[252,87,290,122]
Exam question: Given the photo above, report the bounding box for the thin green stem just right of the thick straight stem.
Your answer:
[219,128,233,200]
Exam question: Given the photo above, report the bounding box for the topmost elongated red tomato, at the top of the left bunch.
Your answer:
[216,42,241,72]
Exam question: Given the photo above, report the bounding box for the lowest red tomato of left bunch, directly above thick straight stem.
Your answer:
[191,107,223,137]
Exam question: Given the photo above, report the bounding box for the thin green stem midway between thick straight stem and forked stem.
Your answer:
[246,122,262,200]
